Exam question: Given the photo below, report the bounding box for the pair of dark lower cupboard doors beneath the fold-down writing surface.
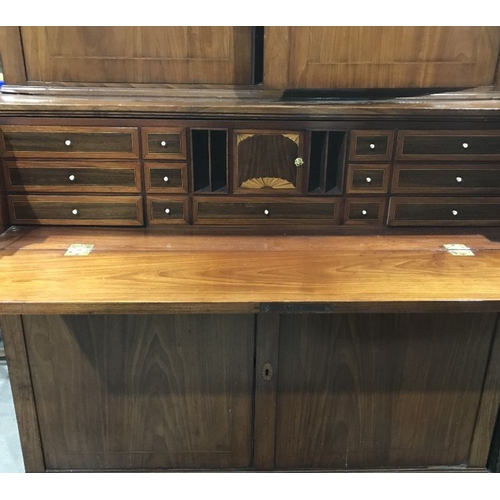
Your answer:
[2,313,500,471]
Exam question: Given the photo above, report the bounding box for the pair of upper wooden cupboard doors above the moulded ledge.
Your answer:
[0,26,500,90]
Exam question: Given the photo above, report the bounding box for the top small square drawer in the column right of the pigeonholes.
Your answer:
[349,130,394,161]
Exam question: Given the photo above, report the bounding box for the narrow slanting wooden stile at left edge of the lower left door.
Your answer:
[0,316,45,472]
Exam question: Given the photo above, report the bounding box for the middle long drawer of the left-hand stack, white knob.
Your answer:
[4,160,141,193]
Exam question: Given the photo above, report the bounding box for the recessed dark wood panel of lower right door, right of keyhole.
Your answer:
[276,314,496,469]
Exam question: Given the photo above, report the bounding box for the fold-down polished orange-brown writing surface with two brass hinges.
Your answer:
[0,228,500,314]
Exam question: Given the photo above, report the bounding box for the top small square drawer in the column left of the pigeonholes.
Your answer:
[142,127,186,160]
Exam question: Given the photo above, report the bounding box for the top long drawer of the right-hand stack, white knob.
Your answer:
[396,130,500,160]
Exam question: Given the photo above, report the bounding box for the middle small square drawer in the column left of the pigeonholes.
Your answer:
[144,163,188,193]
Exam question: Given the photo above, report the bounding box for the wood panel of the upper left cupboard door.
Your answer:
[21,26,252,84]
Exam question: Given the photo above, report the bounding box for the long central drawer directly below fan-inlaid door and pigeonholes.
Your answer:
[193,197,339,225]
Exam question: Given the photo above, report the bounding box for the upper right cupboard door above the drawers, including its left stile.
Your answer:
[264,26,500,89]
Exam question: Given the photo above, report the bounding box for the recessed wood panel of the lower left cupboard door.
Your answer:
[23,315,255,469]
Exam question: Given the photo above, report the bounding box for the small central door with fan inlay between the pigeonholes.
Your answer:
[233,130,305,194]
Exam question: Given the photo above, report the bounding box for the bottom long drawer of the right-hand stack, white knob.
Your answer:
[388,198,500,226]
